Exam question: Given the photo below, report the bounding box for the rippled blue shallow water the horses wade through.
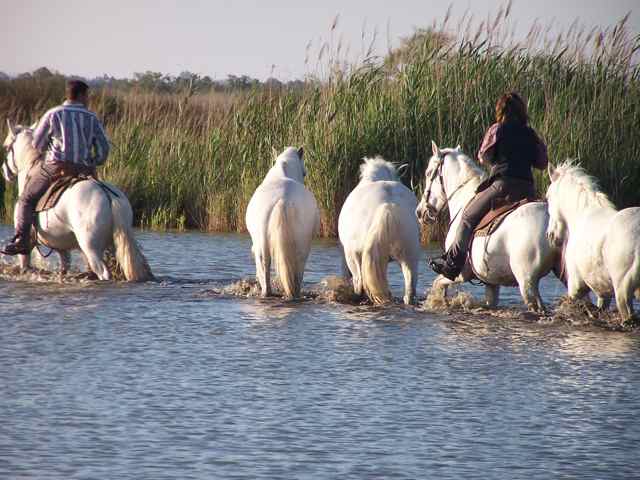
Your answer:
[0,226,640,479]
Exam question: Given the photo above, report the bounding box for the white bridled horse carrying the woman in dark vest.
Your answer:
[416,142,558,312]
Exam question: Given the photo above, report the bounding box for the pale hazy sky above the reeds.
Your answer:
[0,0,640,81]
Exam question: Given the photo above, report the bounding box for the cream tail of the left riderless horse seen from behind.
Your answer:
[267,200,302,298]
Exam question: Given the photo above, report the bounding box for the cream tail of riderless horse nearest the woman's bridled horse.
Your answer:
[362,203,401,304]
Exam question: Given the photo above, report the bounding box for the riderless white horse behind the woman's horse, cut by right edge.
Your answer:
[547,162,640,321]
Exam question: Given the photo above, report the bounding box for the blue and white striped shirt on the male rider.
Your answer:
[33,100,109,167]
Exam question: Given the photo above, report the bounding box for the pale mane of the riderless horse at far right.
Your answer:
[553,159,616,210]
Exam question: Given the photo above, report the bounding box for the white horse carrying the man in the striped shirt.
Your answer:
[2,121,153,281]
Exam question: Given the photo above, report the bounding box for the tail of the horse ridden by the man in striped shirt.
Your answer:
[111,195,153,282]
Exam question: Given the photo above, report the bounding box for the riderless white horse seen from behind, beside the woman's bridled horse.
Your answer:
[338,157,420,304]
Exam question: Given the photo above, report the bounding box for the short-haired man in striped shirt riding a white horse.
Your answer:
[4,80,109,255]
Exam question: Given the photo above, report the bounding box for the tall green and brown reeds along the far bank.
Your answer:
[0,9,640,236]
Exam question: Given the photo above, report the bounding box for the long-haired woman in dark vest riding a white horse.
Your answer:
[430,92,548,280]
